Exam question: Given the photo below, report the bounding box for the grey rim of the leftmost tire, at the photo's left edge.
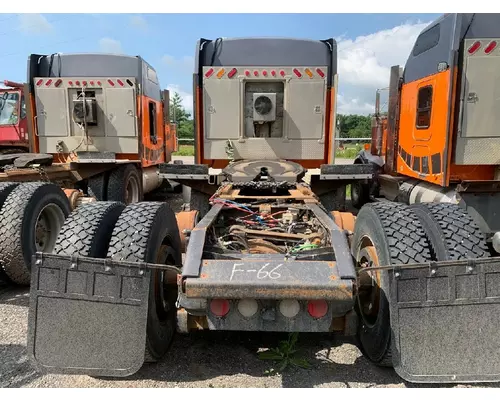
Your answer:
[35,204,66,253]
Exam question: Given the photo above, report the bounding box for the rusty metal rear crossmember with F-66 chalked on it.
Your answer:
[184,259,353,302]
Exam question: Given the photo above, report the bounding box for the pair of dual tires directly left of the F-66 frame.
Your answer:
[54,201,182,362]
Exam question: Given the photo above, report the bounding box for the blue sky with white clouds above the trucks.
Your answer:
[0,14,439,115]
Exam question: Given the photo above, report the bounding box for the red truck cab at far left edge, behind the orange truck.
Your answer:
[0,81,29,154]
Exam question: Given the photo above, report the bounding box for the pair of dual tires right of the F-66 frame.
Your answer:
[352,202,490,367]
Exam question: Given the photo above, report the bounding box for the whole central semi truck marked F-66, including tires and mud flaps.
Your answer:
[28,33,500,382]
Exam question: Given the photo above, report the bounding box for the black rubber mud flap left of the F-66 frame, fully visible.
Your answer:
[28,253,151,377]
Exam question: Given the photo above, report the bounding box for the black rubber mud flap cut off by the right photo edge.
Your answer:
[389,259,500,383]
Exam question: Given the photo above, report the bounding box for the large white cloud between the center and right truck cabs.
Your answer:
[337,22,428,114]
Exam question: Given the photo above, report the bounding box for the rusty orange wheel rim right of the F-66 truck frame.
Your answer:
[356,236,380,327]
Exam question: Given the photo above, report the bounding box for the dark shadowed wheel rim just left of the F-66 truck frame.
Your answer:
[153,244,177,324]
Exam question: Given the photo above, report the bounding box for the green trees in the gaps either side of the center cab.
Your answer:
[170,92,372,139]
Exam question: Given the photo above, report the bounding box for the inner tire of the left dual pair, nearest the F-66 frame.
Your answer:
[108,202,182,362]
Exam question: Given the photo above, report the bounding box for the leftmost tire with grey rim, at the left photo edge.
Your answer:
[0,182,71,285]
